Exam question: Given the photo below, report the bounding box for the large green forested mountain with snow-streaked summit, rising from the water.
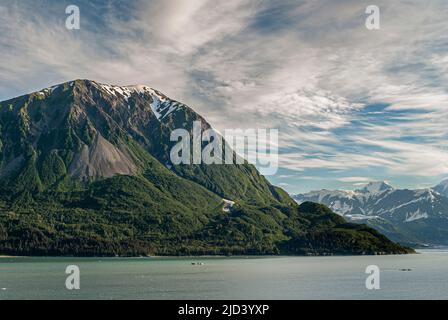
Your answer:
[0,80,410,255]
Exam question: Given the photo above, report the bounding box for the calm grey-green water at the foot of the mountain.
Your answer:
[0,250,448,300]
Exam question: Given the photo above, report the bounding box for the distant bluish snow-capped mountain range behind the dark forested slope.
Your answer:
[293,179,448,245]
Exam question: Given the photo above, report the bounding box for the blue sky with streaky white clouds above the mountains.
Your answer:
[0,0,448,193]
